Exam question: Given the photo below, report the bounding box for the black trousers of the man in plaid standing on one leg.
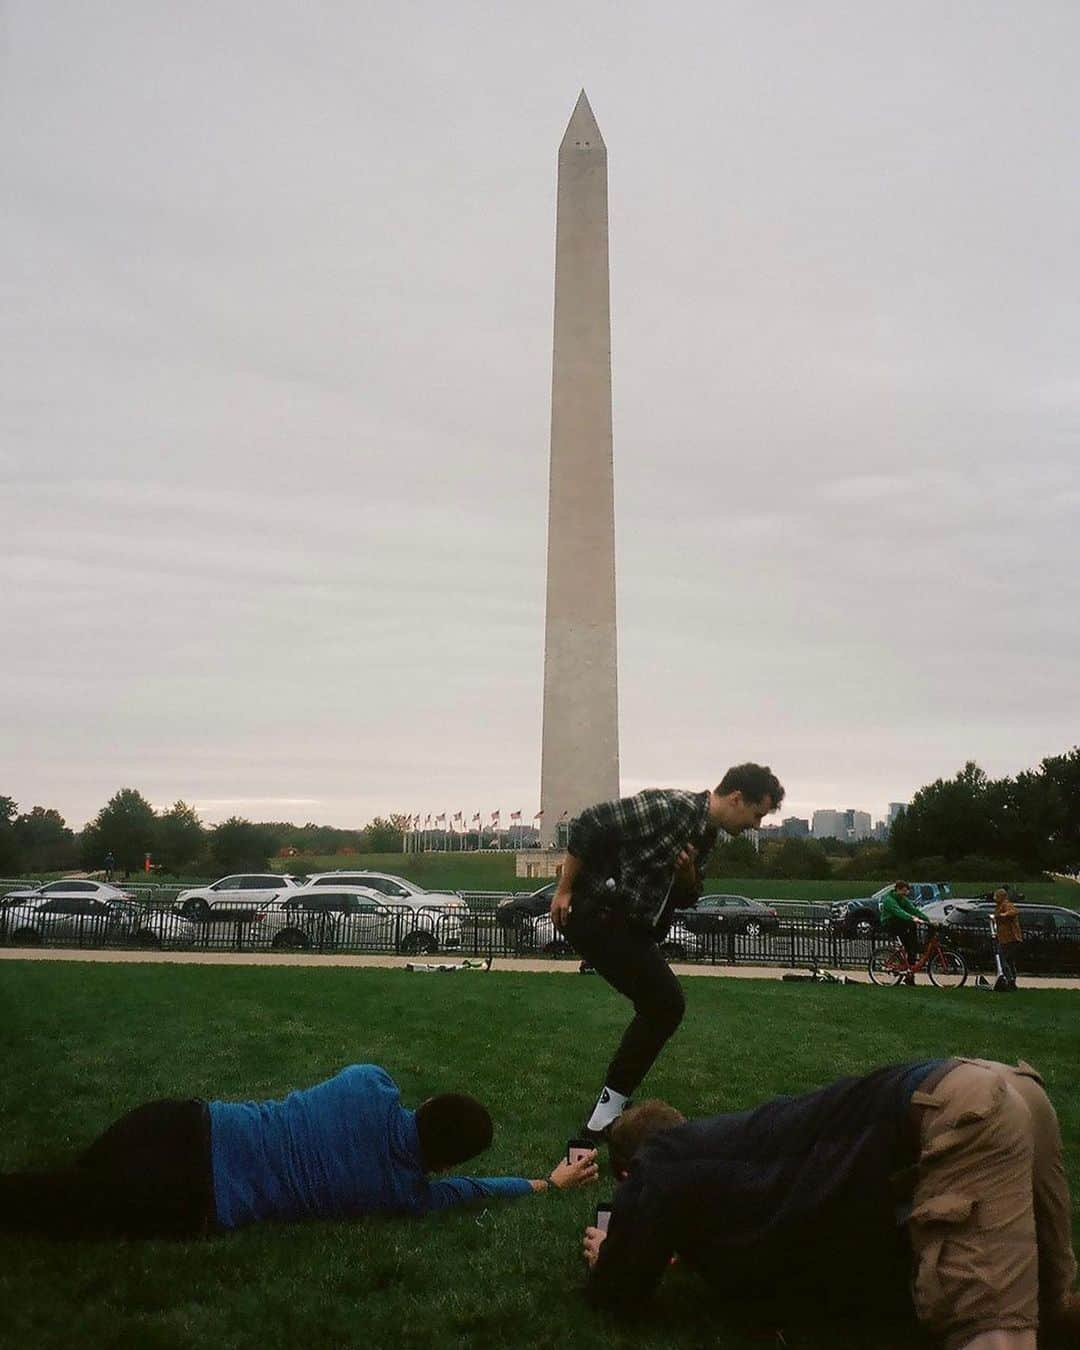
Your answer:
[566,906,686,1096]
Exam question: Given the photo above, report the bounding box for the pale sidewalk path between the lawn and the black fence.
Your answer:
[0,946,1080,990]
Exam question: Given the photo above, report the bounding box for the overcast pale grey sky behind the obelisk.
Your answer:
[0,0,1080,826]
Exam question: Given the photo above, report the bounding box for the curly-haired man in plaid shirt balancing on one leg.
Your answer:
[551,764,784,1141]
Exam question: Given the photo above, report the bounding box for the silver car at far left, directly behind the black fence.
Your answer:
[7,895,196,946]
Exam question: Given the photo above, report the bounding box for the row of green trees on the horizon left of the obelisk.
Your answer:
[0,787,404,876]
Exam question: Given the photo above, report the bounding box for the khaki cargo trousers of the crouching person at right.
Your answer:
[909,1060,1076,1350]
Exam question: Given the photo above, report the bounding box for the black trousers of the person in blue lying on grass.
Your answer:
[0,1100,215,1238]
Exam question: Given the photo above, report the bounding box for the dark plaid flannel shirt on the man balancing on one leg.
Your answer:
[567,787,717,927]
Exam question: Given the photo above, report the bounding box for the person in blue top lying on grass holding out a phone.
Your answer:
[0,1064,597,1238]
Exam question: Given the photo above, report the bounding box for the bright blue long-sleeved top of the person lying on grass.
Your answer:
[209,1064,532,1229]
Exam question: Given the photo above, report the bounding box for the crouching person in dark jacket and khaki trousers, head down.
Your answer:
[583,1060,1080,1350]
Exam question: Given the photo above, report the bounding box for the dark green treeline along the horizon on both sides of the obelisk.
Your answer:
[0,747,1080,880]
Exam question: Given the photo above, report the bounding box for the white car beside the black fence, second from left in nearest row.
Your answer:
[257,886,450,956]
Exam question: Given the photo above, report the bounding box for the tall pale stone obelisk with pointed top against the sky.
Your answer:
[540,90,618,844]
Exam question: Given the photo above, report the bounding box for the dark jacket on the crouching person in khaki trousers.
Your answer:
[590,1060,941,1310]
